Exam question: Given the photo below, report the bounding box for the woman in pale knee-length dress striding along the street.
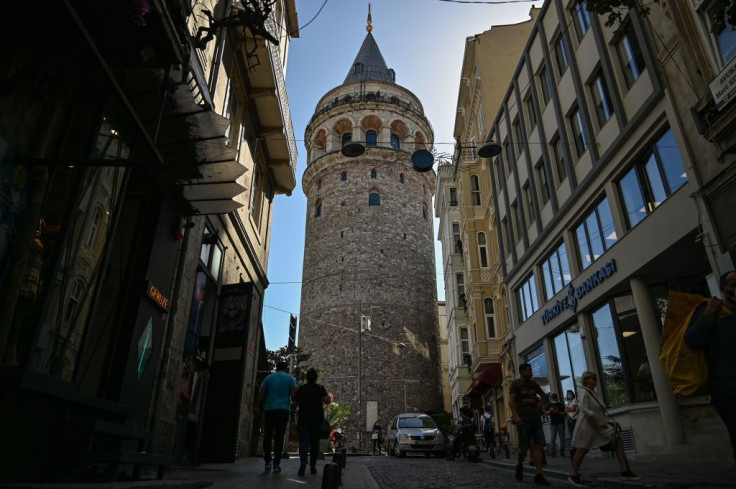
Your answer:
[567,372,641,487]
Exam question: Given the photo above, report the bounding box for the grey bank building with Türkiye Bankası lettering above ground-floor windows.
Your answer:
[480,1,728,457]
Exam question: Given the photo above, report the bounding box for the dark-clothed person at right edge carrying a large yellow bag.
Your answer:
[685,270,736,461]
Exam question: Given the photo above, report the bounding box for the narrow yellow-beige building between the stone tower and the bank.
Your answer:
[436,8,539,429]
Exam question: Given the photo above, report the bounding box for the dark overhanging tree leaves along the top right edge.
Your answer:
[585,0,736,36]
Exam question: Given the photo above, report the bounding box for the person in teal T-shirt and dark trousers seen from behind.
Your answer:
[253,362,296,473]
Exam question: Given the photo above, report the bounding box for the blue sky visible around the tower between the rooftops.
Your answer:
[263,0,542,350]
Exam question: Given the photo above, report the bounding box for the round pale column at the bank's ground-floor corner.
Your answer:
[629,277,685,445]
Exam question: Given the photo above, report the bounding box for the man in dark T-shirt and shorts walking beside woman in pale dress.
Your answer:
[509,363,550,486]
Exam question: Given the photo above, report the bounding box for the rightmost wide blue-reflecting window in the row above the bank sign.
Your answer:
[619,129,687,228]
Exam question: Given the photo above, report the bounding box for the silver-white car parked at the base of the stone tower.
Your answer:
[386,413,445,457]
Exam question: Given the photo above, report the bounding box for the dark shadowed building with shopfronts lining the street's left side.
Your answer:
[0,0,298,481]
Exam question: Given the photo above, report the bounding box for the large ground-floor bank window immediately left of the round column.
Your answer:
[591,294,654,407]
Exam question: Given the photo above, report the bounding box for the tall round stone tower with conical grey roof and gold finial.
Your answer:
[299,12,442,448]
